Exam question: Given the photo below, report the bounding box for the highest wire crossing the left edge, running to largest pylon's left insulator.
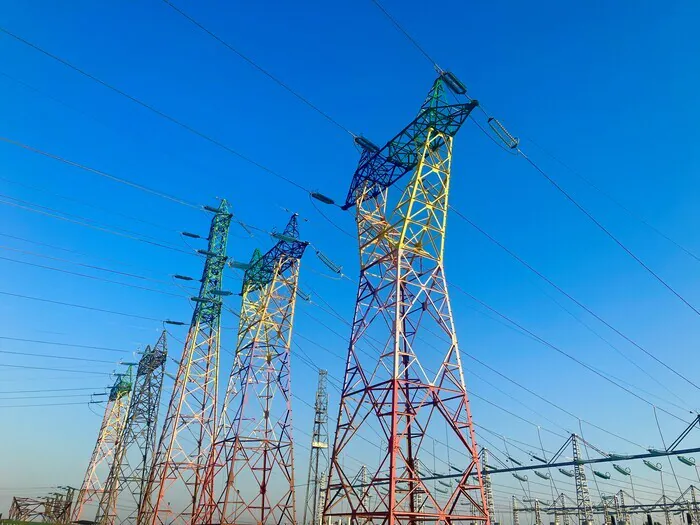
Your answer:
[0,27,311,193]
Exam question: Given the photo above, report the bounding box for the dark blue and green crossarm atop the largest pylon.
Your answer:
[342,77,479,210]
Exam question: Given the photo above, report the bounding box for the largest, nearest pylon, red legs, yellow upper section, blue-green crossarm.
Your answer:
[324,73,488,525]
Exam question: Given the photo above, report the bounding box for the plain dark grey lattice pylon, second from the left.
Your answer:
[95,330,168,525]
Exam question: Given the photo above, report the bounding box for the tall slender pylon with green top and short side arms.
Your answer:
[138,200,232,525]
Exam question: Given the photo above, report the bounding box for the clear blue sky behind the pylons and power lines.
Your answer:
[0,0,700,520]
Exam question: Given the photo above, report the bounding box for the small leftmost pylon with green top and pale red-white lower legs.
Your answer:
[72,366,132,521]
